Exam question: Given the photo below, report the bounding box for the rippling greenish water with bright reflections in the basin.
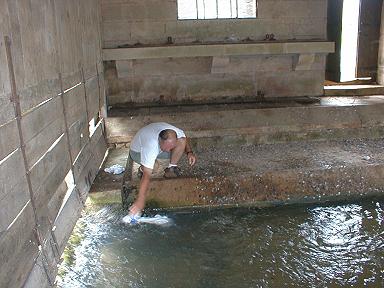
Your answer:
[58,198,384,287]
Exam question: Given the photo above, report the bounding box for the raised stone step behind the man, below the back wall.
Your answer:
[106,96,384,150]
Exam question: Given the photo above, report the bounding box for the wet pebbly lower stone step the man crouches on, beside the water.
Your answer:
[122,138,384,208]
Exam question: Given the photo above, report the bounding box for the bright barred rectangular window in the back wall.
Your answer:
[177,0,257,20]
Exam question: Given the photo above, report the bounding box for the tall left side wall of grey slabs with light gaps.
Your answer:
[0,0,106,287]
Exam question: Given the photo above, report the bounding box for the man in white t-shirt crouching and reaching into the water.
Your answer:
[129,122,196,215]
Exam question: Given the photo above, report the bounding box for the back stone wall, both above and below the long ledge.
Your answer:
[102,0,327,105]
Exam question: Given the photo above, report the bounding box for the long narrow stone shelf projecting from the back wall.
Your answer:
[103,41,335,61]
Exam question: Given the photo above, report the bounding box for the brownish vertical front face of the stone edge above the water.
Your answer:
[121,156,384,210]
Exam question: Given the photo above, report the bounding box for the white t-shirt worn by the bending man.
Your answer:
[131,122,185,169]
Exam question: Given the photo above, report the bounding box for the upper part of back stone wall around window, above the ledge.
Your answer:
[101,0,327,48]
